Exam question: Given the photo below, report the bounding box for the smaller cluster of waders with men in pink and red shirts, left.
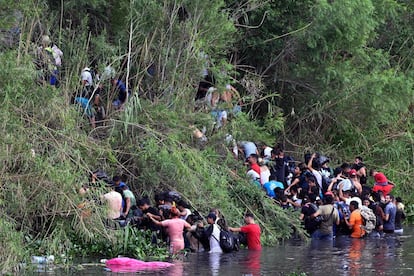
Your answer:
[79,170,261,254]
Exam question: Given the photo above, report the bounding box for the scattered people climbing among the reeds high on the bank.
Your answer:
[35,35,241,134]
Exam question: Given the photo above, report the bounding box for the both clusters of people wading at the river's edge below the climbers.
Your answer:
[80,141,405,254]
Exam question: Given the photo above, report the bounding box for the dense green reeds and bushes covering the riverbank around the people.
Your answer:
[0,0,414,273]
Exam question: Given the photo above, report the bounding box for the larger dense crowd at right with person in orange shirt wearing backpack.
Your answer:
[238,141,405,239]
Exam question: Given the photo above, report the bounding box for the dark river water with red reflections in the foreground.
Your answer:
[34,227,414,276]
